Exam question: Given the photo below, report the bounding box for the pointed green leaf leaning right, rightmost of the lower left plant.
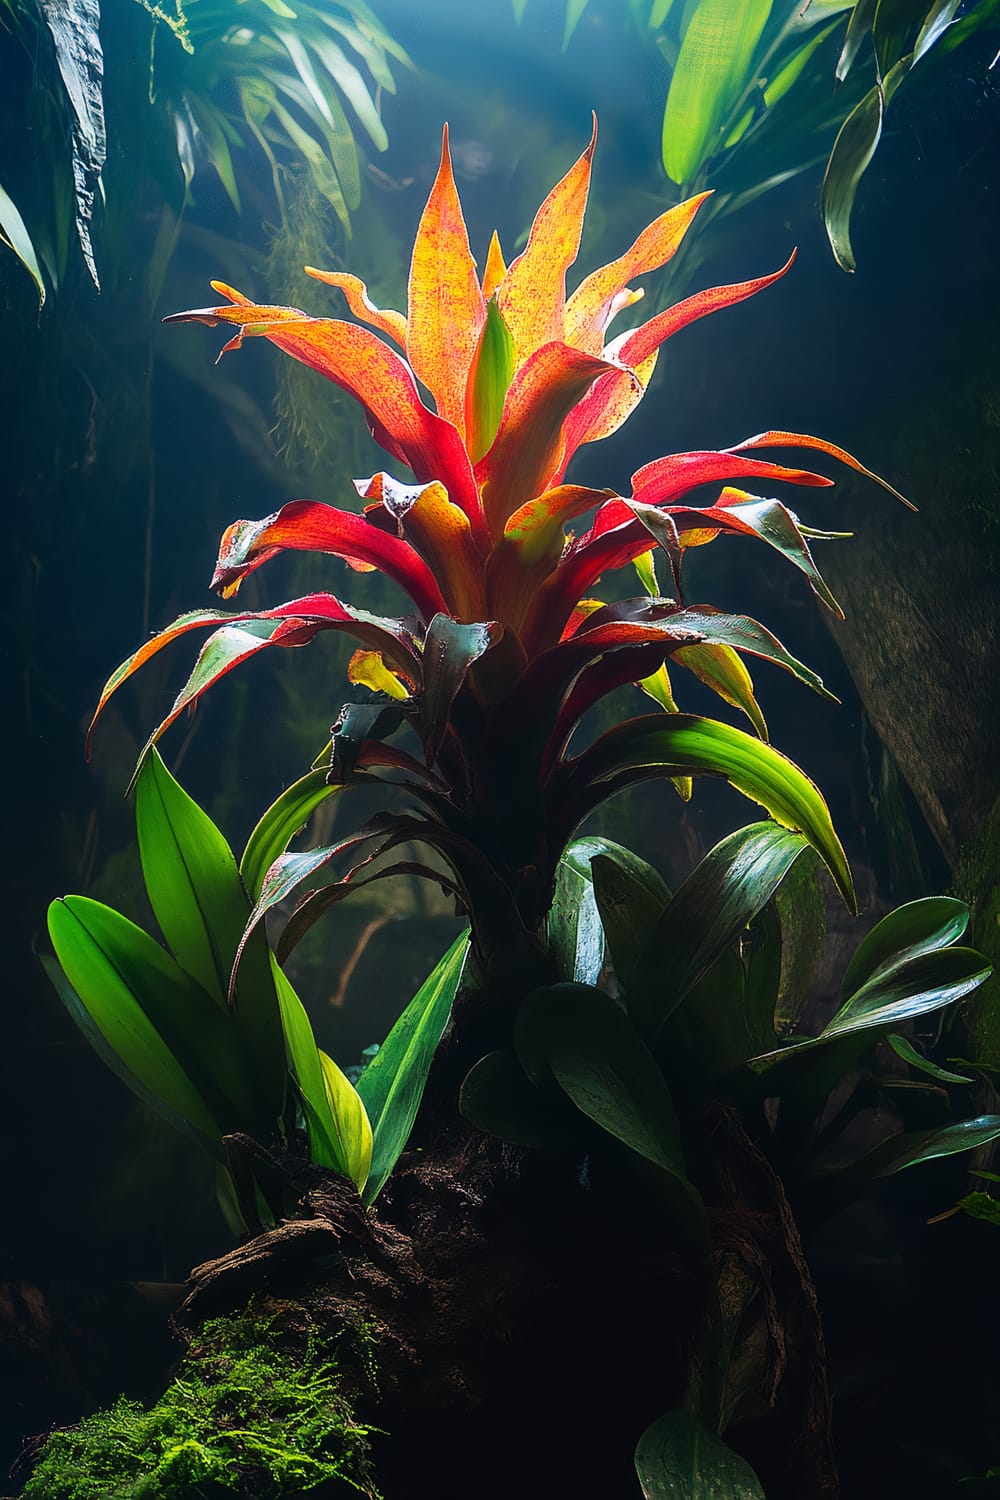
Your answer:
[358,930,469,1203]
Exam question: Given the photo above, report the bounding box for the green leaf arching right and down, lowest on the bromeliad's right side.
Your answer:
[570,714,858,912]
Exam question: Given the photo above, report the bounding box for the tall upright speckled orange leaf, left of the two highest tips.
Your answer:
[406,125,486,435]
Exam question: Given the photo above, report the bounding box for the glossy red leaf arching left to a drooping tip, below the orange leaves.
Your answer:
[211,500,448,620]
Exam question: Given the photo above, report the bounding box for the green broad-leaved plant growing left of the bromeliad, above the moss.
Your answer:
[46,752,466,1229]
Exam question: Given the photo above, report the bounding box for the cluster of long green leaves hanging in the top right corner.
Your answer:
[514,0,1000,272]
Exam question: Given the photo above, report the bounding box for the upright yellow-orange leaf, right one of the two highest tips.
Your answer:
[496,116,597,365]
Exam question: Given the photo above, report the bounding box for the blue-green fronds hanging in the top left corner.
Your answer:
[0,0,409,305]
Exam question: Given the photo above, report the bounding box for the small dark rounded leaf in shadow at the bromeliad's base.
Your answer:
[459,1047,579,1151]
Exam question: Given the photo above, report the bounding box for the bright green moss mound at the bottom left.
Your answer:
[24,1314,378,1500]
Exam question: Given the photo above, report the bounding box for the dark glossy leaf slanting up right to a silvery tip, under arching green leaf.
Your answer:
[628,824,808,1037]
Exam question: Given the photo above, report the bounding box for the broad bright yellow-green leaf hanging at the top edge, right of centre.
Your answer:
[663,0,772,186]
